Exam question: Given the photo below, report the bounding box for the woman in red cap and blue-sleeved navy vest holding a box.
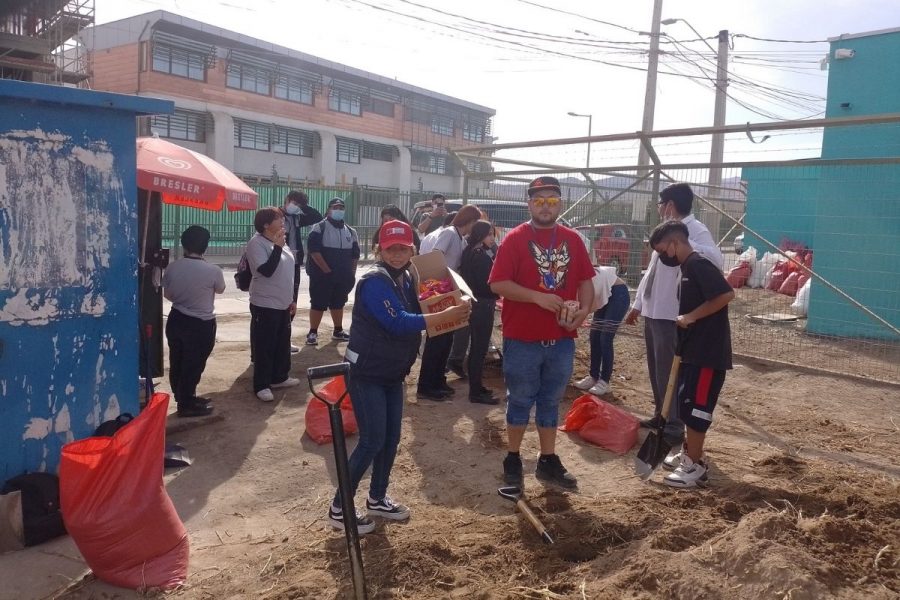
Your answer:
[328,221,470,534]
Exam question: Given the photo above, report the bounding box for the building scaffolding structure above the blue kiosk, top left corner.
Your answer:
[0,0,94,87]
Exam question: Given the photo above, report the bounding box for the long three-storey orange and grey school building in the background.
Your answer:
[83,10,496,194]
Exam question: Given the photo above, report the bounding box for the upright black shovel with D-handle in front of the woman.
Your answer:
[306,363,368,600]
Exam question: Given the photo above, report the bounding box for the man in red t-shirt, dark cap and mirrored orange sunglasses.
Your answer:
[488,177,594,489]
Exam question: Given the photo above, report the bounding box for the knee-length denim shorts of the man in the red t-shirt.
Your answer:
[503,338,575,427]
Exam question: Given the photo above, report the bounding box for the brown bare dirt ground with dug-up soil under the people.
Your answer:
[60,314,900,600]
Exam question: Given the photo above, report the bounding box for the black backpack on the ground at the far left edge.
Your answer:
[0,473,66,546]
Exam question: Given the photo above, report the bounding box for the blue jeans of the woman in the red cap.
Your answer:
[332,372,403,506]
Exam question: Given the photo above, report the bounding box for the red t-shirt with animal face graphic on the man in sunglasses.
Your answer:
[488,223,594,342]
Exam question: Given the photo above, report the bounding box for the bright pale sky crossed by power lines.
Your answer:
[96,0,900,165]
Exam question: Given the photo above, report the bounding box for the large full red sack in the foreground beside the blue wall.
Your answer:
[59,393,190,590]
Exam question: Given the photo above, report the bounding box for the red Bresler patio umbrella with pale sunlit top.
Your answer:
[137,137,258,211]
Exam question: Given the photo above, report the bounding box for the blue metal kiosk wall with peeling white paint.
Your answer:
[0,81,172,481]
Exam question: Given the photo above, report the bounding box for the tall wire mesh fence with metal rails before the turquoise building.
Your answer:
[452,115,900,383]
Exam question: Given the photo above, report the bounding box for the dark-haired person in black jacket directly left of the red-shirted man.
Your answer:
[459,221,499,404]
